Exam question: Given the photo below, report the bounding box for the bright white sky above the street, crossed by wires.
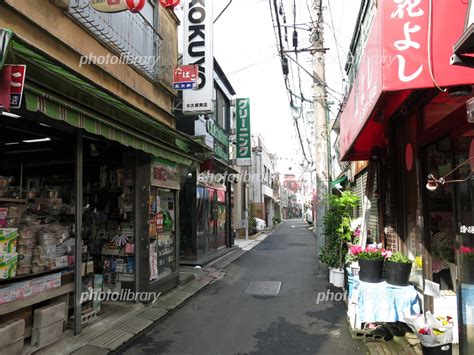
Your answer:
[177,0,360,174]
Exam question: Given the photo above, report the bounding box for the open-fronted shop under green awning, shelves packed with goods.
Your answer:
[0,30,206,346]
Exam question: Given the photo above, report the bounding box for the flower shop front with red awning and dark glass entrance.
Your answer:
[340,1,474,354]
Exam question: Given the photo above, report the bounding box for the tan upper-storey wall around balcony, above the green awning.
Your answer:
[0,0,179,127]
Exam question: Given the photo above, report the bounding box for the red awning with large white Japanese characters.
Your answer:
[340,0,474,160]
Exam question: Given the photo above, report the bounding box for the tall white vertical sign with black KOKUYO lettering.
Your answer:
[183,0,214,115]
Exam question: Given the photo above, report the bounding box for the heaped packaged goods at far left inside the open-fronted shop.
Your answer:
[0,177,74,279]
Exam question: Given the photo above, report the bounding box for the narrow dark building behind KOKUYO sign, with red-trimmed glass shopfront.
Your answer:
[176,60,238,264]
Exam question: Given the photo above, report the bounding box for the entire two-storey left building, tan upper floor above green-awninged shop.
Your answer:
[0,0,210,342]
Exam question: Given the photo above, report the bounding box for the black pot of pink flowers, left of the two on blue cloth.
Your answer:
[357,244,390,283]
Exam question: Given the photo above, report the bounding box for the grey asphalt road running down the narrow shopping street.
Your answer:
[118,220,367,355]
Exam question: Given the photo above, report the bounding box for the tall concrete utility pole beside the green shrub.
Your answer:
[310,0,330,264]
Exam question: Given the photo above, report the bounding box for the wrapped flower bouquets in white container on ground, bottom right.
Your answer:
[405,311,453,354]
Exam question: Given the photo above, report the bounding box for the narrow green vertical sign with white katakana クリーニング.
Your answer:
[236,99,252,166]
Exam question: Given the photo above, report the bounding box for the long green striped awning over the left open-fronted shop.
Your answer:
[5,34,208,166]
